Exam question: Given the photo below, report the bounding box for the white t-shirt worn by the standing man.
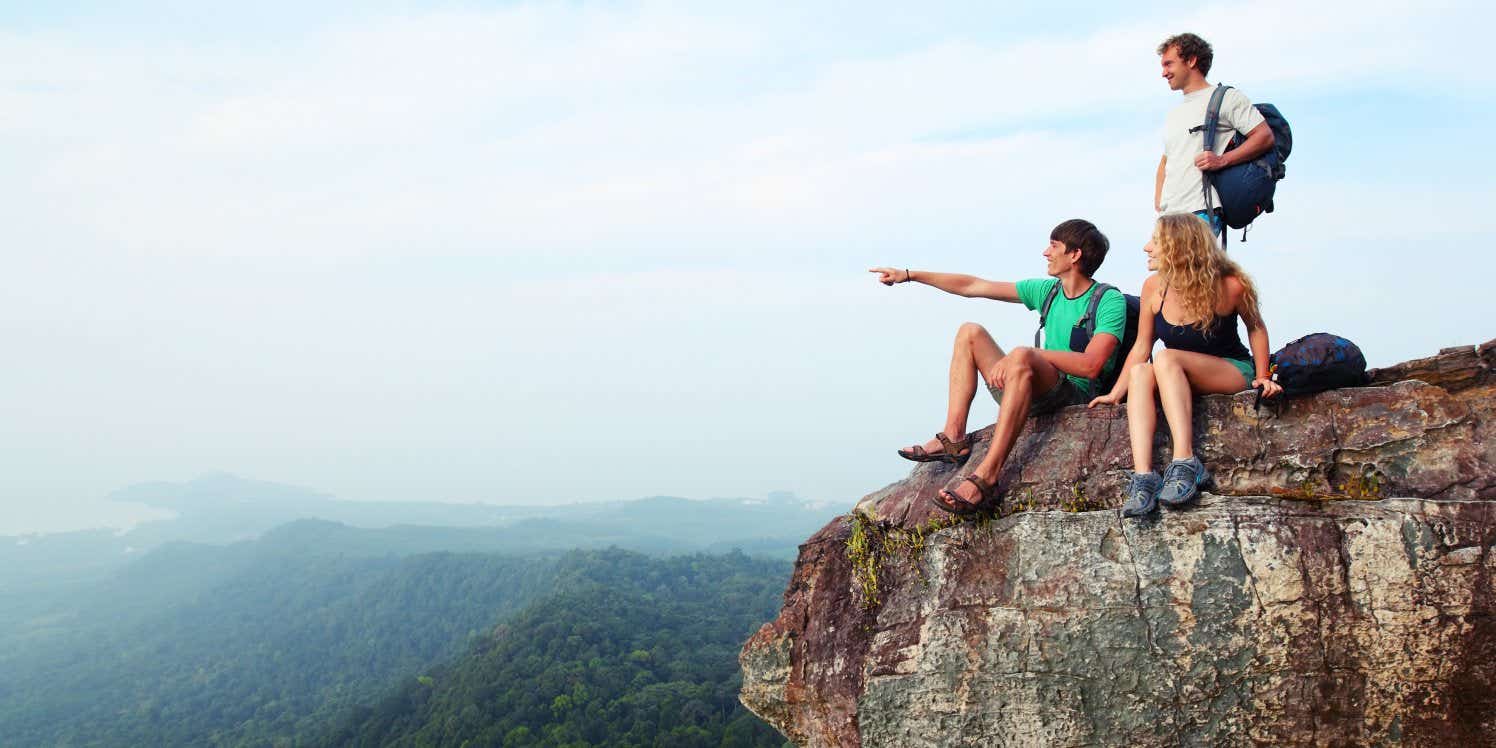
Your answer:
[1158,85,1264,212]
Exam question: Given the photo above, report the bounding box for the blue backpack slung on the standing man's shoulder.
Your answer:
[1203,84,1294,241]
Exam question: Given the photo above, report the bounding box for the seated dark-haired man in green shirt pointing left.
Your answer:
[871,218,1126,515]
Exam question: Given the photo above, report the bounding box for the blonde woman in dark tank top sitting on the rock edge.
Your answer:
[1091,212,1281,516]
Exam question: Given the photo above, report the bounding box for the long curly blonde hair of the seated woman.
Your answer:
[1153,212,1261,332]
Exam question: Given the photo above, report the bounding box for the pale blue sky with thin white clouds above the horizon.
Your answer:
[0,0,1496,534]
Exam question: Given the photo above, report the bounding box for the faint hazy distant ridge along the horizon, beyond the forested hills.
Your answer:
[0,473,836,592]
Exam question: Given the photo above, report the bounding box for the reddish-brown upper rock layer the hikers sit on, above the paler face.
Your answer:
[857,341,1496,527]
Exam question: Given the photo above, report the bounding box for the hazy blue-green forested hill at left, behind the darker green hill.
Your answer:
[0,546,556,745]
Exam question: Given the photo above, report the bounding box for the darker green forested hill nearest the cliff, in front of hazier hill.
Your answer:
[319,551,788,748]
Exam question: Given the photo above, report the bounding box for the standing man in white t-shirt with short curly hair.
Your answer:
[1153,33,1273,233]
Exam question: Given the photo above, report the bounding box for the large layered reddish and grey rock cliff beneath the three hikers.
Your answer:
[741,341,1496,747]
